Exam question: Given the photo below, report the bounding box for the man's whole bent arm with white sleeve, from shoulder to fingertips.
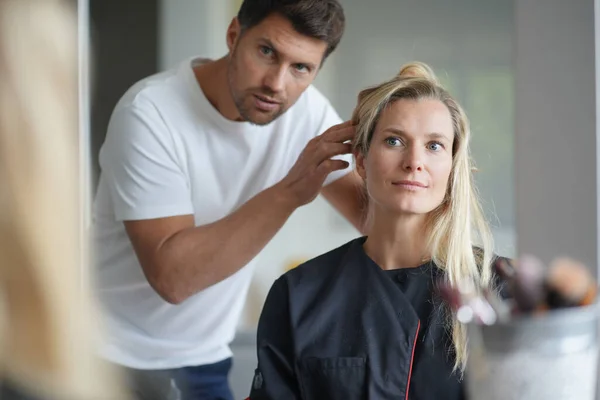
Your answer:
[103,103,354,304]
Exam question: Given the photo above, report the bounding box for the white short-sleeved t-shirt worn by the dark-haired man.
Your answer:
[93,56,350,369]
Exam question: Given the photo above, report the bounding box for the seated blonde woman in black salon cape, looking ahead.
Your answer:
[250,63,502,400]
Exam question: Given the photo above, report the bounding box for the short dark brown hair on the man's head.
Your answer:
[237,0,346,60]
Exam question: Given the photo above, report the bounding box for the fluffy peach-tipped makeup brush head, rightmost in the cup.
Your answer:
[545,258,597,308]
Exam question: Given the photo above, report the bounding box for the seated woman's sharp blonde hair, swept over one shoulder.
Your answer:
[353,62,493,372]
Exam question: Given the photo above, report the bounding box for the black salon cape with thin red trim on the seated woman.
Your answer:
[250,238,492,400]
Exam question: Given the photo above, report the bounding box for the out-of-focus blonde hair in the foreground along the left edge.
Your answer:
[0,0,122,400]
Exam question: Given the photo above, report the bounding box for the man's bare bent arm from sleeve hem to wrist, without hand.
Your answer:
[124,181,296,304]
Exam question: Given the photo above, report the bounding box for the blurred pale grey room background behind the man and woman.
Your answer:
[87,0,600,398]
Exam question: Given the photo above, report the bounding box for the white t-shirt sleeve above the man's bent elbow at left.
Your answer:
[99,105,193,221]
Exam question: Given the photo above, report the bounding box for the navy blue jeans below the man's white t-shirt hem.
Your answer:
[173,358,233,400]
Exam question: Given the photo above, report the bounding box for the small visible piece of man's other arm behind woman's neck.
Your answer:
[321,171,367,235]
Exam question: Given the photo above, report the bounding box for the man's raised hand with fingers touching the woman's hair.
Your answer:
[277,121,356,207]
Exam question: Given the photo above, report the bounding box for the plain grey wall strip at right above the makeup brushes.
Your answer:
[515,0,598,270]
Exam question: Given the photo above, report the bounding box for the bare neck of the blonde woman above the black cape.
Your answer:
[364,211,429,270]
